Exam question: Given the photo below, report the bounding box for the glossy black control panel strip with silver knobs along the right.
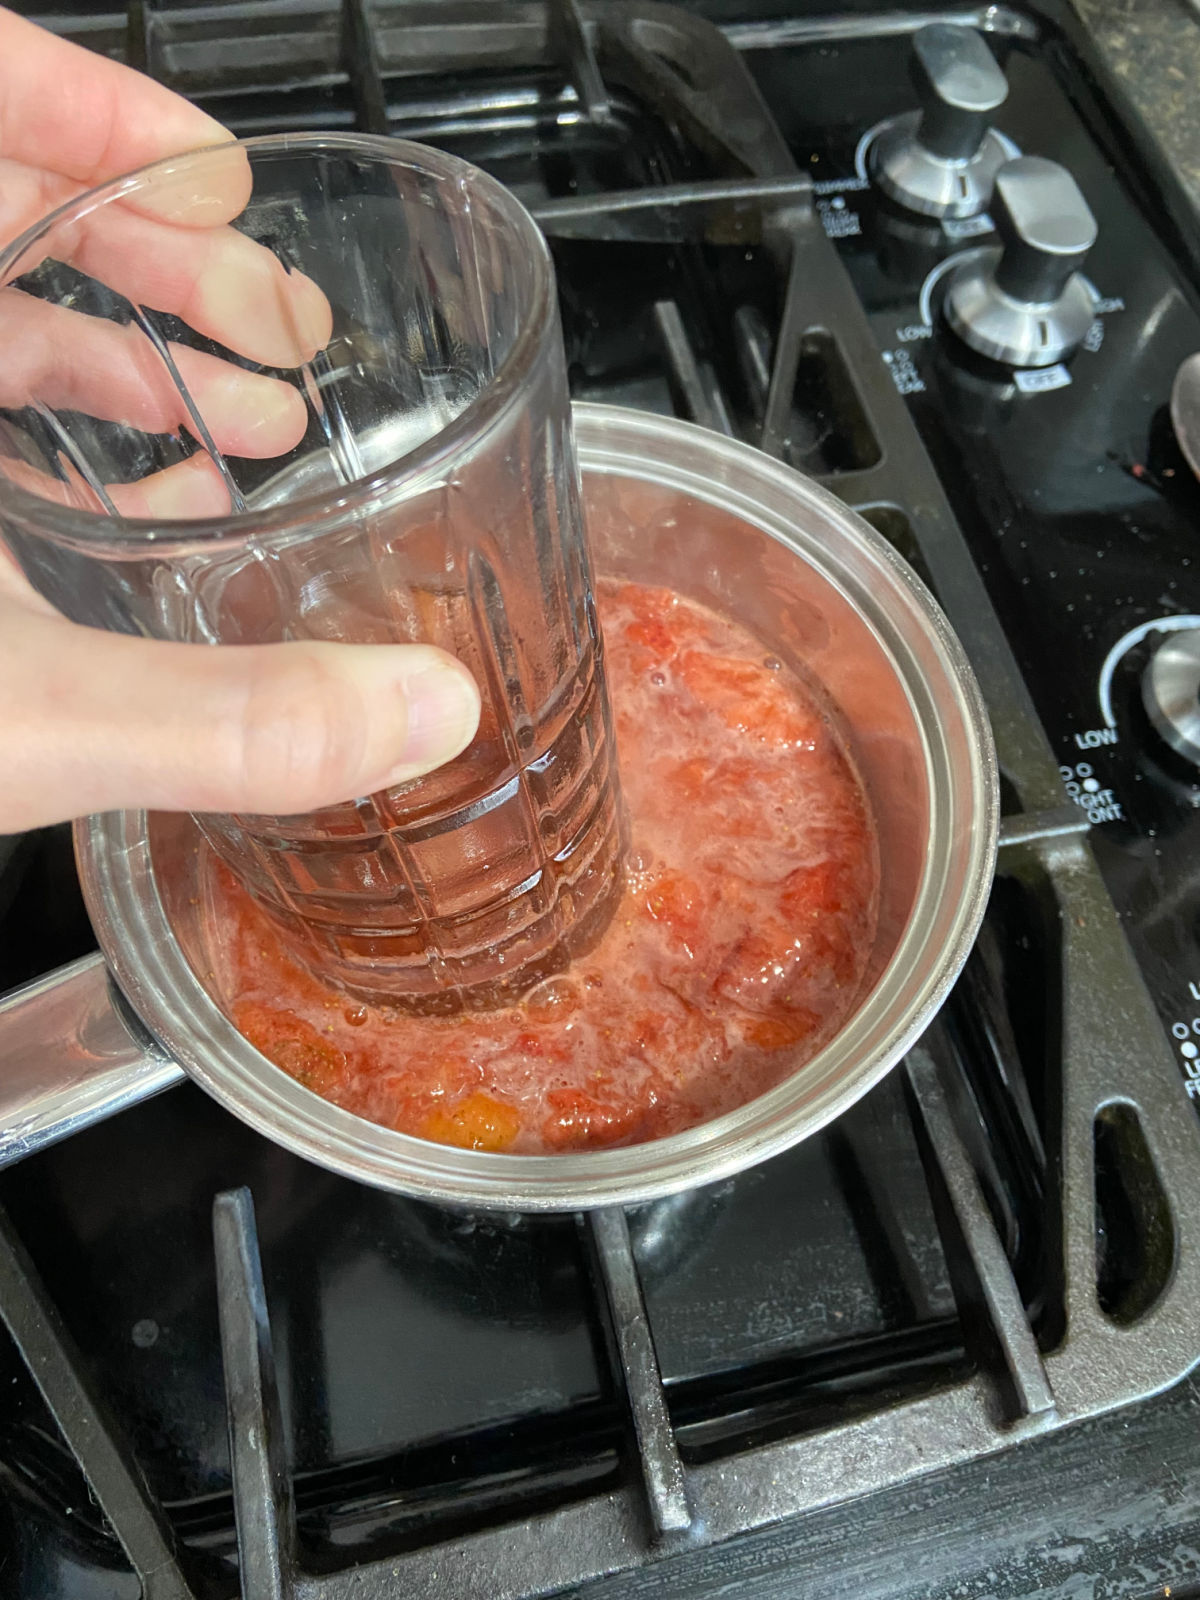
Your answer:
[749,6,1200,1088]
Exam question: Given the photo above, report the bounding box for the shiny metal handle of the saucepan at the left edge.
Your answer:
[0,952,184,1166]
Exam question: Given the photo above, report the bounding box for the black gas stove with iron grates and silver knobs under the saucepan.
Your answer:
[0,0,1200,1600]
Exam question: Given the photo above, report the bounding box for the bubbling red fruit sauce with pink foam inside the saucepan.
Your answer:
[210,581,878,1154]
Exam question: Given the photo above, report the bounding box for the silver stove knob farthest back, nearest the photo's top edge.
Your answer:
[874,22,1008,216]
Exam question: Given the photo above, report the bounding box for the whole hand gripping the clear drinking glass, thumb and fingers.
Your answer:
[0,10,478,832]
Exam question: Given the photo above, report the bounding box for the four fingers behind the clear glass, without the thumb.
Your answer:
[0,10,331,499]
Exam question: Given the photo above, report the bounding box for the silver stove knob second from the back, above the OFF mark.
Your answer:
[946,155,1096,366]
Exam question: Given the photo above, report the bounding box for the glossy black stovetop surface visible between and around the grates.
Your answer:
[0,0,1200,1600]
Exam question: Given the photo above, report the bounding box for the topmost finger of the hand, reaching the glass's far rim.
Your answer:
[0,10,240,209]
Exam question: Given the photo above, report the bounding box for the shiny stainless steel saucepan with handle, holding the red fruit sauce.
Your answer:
[0,405,998,1211]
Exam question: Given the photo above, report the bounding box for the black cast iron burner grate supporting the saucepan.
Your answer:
[0,0,1200,1600]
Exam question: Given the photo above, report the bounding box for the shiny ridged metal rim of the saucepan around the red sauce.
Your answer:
[75,403,1000,1211]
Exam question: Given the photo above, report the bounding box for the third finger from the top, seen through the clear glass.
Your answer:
[0,290,307,458]
